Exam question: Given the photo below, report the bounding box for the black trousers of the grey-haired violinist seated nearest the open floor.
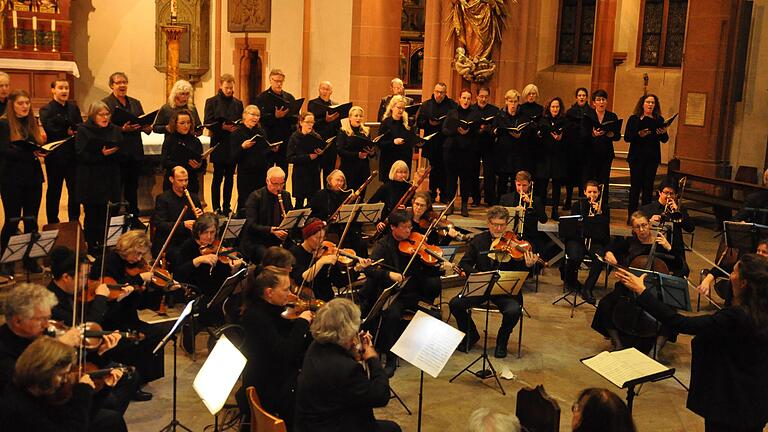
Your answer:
[448,295,523,340]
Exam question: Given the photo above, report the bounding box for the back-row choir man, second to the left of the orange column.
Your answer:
[255,69,297,172]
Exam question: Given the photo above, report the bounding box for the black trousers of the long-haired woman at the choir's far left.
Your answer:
[0,182,43,252]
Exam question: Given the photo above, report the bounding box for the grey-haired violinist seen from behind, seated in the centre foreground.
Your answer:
[296,298,400,432]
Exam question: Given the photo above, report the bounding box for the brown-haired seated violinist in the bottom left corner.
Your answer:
[0,337,128,432]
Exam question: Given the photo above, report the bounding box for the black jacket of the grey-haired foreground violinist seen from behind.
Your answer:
[296,342,389,432]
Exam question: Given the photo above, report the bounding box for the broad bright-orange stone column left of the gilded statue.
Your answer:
[349,0,402,121]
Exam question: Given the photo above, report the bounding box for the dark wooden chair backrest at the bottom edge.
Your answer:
[515,384,560,432]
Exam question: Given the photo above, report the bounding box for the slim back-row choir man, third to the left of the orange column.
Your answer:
[204,73,243,215]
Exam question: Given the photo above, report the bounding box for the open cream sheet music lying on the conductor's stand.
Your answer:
[582,348,669,388]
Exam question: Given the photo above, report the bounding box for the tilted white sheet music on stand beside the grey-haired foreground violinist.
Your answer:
[392,311,464,378]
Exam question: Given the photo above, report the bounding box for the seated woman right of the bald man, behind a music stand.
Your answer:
[309,170,368,257]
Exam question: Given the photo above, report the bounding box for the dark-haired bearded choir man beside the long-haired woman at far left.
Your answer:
[40,79,83,224]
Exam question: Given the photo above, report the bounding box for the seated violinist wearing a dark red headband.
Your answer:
[291,218,371,302]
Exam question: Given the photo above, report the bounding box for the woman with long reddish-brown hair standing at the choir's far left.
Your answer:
[0,90,45,275]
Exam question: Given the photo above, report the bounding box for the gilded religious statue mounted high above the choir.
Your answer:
[448,0,515,83]
